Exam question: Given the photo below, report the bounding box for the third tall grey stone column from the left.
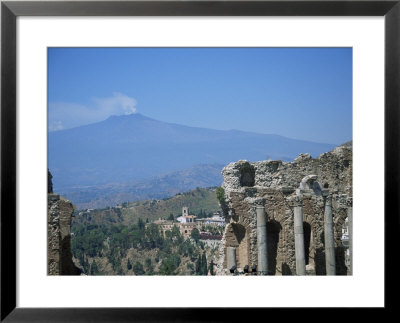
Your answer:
[324,195,336,276]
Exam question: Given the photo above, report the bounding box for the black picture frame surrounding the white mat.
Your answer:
[0,0,400,322]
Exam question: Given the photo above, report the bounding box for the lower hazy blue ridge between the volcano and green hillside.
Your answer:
[60,164,224,210]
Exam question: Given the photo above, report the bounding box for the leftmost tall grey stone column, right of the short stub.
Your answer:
[256,206,268,275]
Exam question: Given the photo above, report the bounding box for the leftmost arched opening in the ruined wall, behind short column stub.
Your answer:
[225,223,249,268]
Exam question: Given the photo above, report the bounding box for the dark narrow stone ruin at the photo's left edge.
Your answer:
[47,172,80,275]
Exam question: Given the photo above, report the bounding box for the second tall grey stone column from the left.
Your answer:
[294,196,306,276]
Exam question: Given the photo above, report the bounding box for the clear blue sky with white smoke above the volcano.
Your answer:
[48,48,352,144]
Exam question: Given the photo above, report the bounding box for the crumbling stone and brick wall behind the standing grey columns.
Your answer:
[217,146,352,275]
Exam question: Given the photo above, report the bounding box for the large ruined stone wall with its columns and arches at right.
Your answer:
[217,146,353,275]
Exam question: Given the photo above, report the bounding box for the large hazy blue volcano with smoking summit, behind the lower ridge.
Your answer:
[48,114,334,192]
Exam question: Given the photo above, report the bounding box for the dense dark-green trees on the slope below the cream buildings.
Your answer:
[71,219,222,275]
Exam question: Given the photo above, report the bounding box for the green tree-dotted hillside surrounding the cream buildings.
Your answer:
[71,188,221,275]
